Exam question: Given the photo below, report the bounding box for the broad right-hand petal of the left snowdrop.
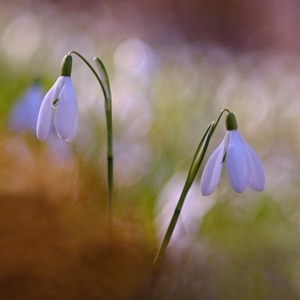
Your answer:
[54,77,77,140]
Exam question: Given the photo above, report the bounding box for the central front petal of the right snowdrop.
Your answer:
[226,130,251,193]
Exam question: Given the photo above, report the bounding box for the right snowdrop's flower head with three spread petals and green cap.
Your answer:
[200,113,265,196]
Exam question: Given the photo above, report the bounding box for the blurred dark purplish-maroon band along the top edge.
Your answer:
[41,0,300,50]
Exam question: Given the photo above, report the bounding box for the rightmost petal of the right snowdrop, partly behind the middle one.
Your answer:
[239,134,265,192]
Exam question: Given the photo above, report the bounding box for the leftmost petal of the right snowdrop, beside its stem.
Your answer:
[200,132,229,196]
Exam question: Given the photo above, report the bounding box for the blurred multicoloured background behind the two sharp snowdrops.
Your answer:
[0,0,300,300]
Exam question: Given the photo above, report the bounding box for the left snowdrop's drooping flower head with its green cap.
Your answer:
[36,55,78,143]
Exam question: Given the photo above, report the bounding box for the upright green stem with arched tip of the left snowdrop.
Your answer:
[68,51,114,245]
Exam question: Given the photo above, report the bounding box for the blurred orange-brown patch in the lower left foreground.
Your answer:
[0,136,154,299]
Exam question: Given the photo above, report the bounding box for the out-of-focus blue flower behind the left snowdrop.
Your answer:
[8,82,45,134]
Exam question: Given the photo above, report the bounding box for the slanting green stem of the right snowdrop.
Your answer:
[153,109,230,272]
